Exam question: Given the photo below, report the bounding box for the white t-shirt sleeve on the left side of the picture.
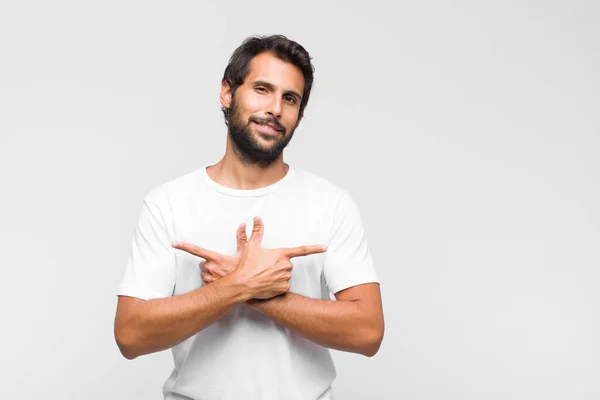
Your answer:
[117,199,176,300]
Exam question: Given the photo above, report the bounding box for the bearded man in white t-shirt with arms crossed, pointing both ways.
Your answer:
[115,35,384,400]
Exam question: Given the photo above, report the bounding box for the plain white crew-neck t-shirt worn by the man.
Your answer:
[117,166,378,400]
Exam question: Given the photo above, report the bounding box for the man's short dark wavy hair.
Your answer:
[221,35,315,125]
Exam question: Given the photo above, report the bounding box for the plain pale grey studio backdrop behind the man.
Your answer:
[0,1,600,400]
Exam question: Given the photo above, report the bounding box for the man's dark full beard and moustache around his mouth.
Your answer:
[227,100,295,168]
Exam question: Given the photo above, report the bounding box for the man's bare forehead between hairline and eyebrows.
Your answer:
[244,53,304,94]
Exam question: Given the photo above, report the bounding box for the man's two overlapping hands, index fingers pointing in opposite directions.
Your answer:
[173,217,327,299]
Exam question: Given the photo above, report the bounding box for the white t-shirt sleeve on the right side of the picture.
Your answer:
[323,192,379,294]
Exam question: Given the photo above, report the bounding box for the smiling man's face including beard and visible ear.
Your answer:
[221,53,304,167]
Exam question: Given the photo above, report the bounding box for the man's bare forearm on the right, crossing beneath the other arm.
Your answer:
[247,282,384,357]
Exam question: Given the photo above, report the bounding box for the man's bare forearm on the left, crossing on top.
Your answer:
[115,277,249,359]
